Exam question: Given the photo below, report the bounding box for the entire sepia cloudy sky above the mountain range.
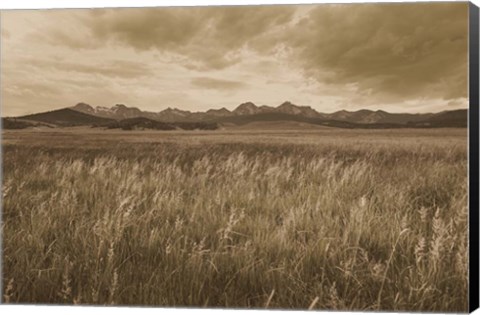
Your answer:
[1,3,468,116]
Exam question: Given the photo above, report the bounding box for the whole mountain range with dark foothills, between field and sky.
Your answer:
[3,102,468,130]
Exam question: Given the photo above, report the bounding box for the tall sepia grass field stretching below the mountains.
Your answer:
[2,129,468,312]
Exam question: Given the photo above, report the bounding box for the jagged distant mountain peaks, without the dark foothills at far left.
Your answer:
[62,101,466,126]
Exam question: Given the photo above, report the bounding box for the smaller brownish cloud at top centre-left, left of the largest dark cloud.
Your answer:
[53,6,295,70]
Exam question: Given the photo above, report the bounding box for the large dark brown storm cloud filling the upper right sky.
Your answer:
[288,3,468,101]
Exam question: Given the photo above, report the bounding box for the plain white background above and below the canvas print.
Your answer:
[0,0,480,315]
